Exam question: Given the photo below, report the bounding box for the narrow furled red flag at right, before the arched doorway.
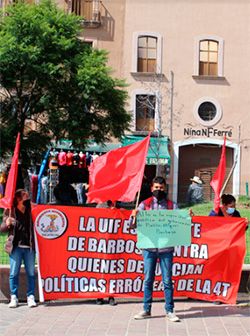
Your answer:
[210,137,226,212]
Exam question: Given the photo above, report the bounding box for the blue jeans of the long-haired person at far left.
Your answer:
[9,247,35,297]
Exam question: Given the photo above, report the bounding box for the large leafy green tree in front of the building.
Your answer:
[0,0,130,162]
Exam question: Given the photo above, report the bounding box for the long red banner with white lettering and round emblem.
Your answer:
[32,205,246,304]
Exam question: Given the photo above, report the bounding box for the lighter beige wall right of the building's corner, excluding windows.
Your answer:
[119,0,250,198]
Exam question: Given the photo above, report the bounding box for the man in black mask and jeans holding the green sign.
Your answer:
[131,176,180,322]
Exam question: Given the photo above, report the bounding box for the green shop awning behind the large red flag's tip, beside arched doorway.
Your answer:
[122,135,171,166]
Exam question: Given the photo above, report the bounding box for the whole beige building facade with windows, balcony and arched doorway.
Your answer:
[3,0,250,202]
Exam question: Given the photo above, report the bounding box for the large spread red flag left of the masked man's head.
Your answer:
[88,135,150,203]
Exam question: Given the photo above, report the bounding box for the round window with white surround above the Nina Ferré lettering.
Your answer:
[194,97,222,126]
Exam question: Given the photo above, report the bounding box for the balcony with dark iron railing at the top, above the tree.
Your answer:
[68,0,102,28]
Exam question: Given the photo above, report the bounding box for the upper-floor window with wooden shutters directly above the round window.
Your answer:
[199,40,219,76]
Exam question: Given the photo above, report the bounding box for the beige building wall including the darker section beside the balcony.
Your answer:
[58,0,250,200]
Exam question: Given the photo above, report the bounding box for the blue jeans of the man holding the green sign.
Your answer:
[143,250,174,312]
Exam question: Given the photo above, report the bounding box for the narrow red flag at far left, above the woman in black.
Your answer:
[0,133,20,209]
